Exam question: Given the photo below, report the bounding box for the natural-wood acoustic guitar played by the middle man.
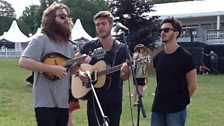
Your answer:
[71,57,150,100]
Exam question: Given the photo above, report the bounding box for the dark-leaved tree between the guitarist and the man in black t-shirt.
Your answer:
[109,0,158,51]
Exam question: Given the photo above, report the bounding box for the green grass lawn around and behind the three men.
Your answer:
[0,58,224,126]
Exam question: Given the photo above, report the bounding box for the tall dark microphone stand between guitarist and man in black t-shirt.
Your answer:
[121,31,146,126]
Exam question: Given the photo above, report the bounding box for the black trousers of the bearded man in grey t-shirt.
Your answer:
[35,108,68,126]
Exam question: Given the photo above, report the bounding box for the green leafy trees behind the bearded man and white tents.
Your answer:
[0,0,108,37]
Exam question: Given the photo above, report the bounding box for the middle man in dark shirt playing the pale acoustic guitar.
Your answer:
[76,11,130,126]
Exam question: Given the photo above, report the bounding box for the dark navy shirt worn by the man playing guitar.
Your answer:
[80,40,128,102]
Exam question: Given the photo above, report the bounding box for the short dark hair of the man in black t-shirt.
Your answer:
[161,17,182,38]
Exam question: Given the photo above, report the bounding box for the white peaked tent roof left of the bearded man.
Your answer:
[2,20,29,42]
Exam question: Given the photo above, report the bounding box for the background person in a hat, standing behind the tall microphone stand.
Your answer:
[133,44,148,106]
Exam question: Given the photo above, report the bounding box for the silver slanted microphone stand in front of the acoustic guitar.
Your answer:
[85,71,109,126]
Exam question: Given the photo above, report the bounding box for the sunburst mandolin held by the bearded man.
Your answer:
[41,48,105,81]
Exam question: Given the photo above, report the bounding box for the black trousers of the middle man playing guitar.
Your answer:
[87,100,122,126]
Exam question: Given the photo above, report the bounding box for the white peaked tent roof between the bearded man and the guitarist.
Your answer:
[72,19,93,40]
